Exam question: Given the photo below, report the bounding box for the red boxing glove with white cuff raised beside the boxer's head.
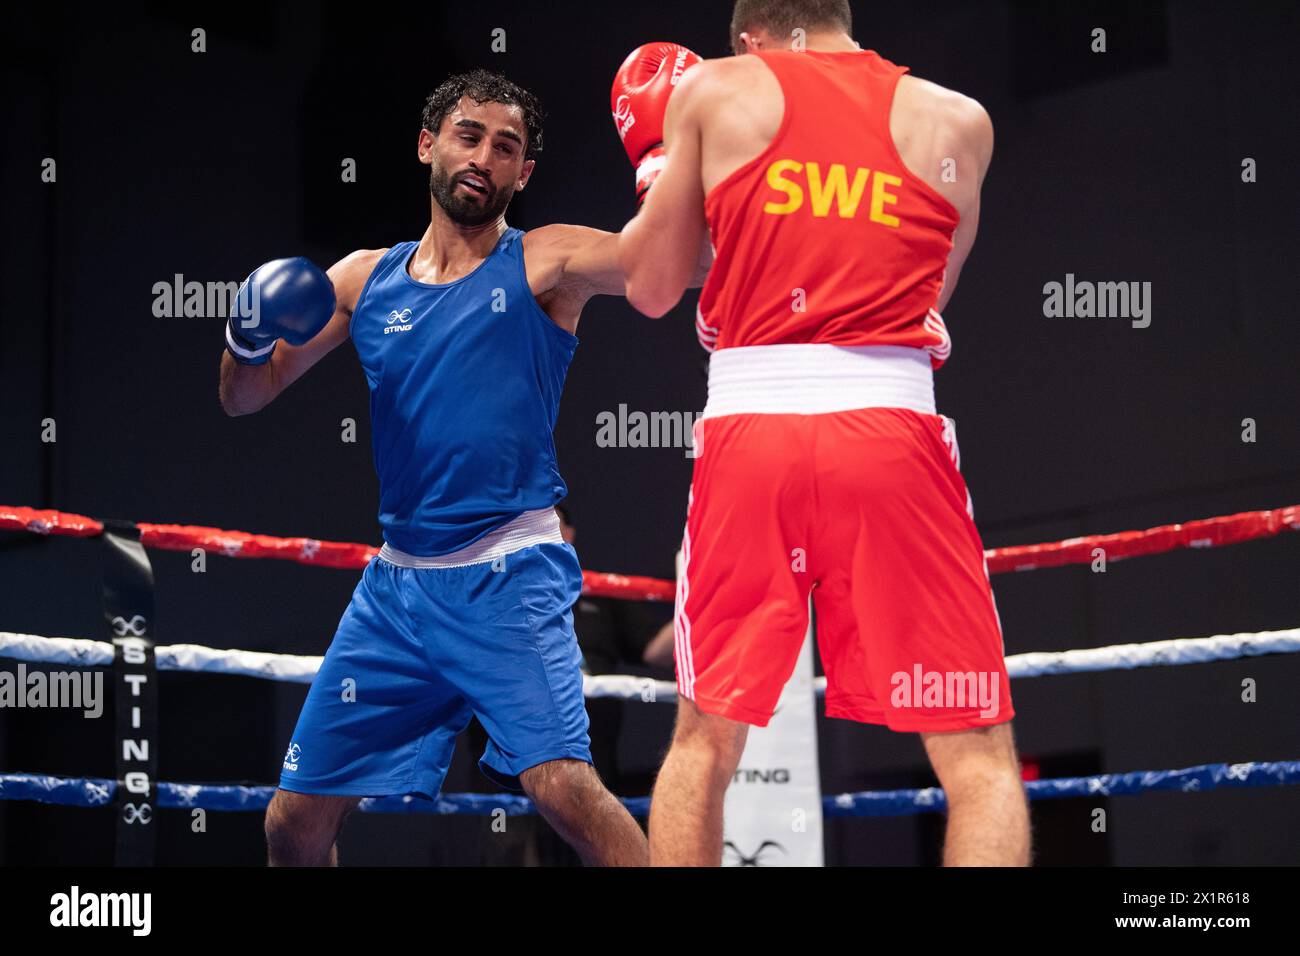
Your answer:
[610,43,701,207]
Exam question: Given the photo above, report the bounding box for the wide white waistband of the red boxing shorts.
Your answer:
[701,343,935,419]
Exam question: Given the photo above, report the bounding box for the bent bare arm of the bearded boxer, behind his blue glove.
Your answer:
[218,248,387,415]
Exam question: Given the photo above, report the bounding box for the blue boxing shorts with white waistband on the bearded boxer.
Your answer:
[280,509,592,799]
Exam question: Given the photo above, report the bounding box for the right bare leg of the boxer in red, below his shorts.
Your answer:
[920,721,1030,866]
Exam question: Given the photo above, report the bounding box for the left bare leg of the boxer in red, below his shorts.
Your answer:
[650,698,749,866]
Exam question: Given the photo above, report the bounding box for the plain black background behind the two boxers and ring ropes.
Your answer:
[0,0,1300,865]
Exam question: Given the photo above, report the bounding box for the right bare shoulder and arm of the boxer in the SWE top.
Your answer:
[889,77,993,312]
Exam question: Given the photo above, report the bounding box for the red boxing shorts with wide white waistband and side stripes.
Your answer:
[675,346,1015,732]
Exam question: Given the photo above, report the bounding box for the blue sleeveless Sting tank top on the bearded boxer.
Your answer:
[348,229,577,557]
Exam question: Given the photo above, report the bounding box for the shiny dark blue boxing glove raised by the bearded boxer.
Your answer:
[226,256,335,365]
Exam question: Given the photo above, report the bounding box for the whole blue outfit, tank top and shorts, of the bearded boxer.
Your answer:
[280,229,592,797]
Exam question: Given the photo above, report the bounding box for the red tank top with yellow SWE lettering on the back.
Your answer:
[696,51,958,368]
